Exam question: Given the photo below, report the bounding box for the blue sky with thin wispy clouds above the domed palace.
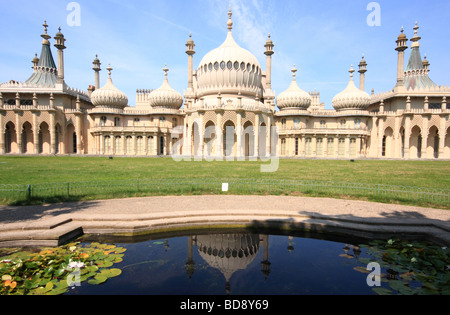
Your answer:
[0,0,450,109]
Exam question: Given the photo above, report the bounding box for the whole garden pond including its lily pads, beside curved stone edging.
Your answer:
[0,229,450,297]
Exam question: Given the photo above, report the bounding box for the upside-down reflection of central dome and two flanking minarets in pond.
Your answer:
[186,234,270,293]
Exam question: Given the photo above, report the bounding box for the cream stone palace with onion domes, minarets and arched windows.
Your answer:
[0,11,450,159]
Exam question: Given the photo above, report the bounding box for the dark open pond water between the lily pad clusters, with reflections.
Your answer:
[62,231,386,295]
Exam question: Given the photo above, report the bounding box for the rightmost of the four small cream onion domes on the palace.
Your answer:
[332,66,370,110]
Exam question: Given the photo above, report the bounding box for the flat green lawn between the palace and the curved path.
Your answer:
[0,156,450,209]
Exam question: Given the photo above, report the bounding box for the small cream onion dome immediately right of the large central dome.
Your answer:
[276,65,312,110]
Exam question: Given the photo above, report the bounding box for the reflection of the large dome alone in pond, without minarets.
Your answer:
[197,234,259,282]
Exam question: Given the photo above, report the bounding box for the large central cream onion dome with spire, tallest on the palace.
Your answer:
[197,12,263,96]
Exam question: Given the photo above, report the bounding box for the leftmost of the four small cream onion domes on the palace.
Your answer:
[91,65,128,108]
